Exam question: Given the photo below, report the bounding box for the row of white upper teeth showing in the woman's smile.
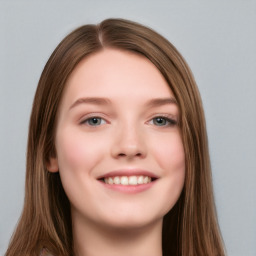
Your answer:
[104,175,152,186]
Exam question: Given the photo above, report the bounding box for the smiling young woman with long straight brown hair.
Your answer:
[6,19,224,256]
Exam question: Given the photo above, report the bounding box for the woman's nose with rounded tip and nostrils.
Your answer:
[111,126,147,160]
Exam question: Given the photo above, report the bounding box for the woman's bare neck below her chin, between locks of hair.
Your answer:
[73,212,162,256]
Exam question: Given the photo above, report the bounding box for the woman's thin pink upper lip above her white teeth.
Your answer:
[97,169,159,179]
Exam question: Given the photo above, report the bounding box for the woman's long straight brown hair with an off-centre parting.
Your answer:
[6,19,225,256]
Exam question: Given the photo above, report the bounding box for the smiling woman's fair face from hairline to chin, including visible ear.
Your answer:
[48,49,185,228]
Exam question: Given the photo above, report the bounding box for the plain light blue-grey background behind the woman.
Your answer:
[0,0,256,256]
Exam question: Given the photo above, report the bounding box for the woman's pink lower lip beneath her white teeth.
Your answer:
[98,181,156,194]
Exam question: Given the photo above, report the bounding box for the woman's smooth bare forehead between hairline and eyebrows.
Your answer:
[63,49,173,106]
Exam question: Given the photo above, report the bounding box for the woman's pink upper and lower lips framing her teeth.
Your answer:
[97,169,159,194]
